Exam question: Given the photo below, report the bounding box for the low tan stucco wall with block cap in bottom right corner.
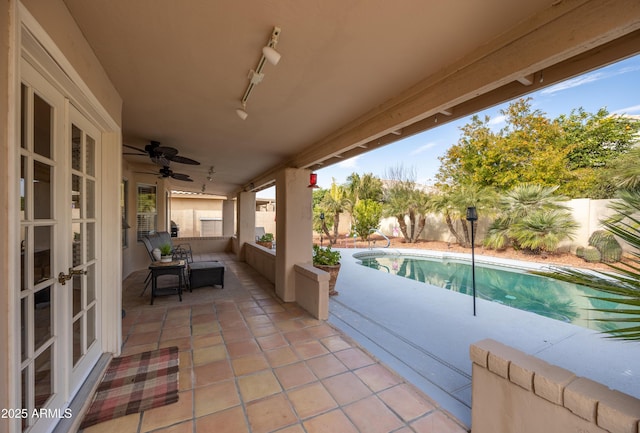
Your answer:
[470,339,640,433]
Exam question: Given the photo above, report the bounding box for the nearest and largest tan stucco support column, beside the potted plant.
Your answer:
[276,168,313,302]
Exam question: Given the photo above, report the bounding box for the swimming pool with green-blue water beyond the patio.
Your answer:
[354,251,620,331]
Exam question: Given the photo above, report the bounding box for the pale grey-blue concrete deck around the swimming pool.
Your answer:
[329,249,640,428]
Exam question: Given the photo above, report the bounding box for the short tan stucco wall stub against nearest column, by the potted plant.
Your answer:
[295,263,329,320]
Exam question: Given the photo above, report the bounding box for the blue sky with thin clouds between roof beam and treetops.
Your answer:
[258,56,640,198]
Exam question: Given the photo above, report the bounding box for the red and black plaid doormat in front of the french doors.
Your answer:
[80,347,178,429]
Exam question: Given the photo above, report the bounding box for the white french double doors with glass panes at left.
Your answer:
[17,60,101,433]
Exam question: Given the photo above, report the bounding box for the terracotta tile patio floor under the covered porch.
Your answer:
[84,250,466,433]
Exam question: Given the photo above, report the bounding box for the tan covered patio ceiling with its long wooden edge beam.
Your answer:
[61,0,640,196]
